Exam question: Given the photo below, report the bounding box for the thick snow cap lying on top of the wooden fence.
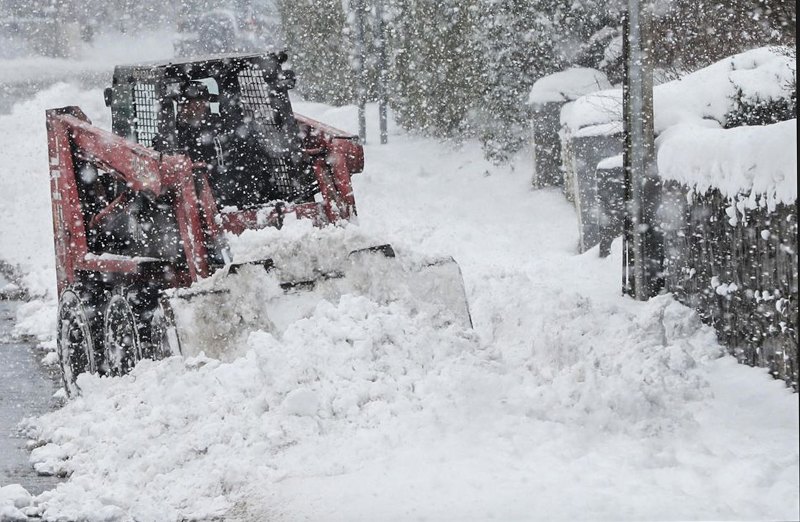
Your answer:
[658,119,797,208]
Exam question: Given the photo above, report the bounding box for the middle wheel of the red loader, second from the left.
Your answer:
[103,295,142,375]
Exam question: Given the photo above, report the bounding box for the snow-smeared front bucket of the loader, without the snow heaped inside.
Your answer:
[168,245,472,360]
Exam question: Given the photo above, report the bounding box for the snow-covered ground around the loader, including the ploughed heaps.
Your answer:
[0,85,800,521]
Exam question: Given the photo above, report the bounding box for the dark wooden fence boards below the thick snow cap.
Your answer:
[661,182,798,390]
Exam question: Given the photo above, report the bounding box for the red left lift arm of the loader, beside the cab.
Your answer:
[46,107,220,293]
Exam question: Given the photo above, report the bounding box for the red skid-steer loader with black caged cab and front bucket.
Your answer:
[46,53,471,395]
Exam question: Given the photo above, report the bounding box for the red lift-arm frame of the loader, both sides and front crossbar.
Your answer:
[46,107,364,293]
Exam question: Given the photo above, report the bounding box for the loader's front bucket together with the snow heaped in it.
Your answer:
[170,219,470,360]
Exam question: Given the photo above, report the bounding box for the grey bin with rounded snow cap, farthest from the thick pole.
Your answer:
[528,67,611,188]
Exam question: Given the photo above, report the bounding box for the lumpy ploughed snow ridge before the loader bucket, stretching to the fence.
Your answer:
[23,291,718,520]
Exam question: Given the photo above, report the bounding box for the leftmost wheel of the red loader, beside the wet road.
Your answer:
[56,289,97,397]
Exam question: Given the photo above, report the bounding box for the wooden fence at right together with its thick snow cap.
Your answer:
[658,119,798,389]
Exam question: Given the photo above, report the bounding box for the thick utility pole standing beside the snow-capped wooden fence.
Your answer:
[622,0,663,300]
